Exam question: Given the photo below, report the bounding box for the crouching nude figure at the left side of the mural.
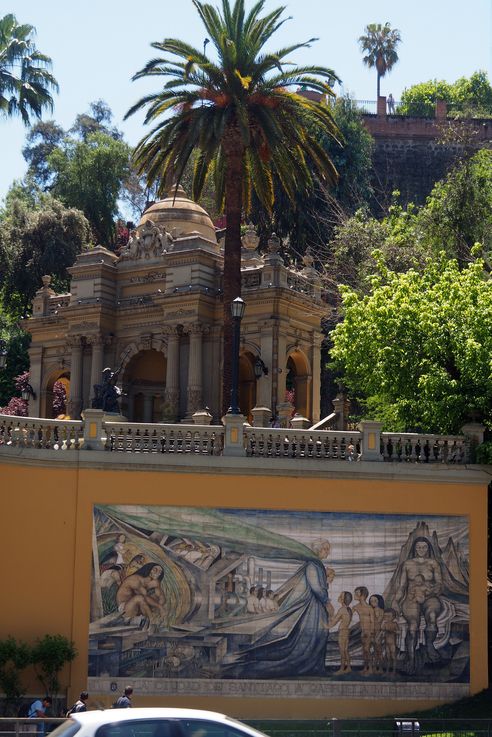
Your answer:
[116,563,165,626]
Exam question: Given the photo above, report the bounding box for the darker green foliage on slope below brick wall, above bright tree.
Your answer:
[324,149,492,291]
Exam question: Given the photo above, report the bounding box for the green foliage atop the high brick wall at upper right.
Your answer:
[398,71,492,118]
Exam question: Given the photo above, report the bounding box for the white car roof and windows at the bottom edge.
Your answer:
[50,708,266,737]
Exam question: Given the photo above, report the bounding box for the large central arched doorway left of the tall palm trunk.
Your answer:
[121,350,166,422]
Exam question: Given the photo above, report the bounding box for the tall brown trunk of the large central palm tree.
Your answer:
[222,132,244,413]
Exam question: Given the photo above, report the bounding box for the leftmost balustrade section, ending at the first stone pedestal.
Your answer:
[0,415,84,450]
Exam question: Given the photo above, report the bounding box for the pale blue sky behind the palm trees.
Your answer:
[0,0,492,203]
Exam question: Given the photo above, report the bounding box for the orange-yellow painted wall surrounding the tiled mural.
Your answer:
[0,459,487,719]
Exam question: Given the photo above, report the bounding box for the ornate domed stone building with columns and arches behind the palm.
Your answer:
[27,188,327,423]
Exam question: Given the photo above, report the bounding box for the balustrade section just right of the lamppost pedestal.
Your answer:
[244,427,361,461]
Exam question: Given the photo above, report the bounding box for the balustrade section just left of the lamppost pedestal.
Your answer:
[104,422,224,455]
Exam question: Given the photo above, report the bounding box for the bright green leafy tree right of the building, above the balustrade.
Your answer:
[331,254,492,433]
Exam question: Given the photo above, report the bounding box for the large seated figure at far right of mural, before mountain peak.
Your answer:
[393,537,442,674]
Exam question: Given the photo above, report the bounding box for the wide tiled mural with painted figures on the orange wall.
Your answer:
[89,506,469,683]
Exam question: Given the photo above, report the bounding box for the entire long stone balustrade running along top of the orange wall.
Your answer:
[0,410,483,465]
